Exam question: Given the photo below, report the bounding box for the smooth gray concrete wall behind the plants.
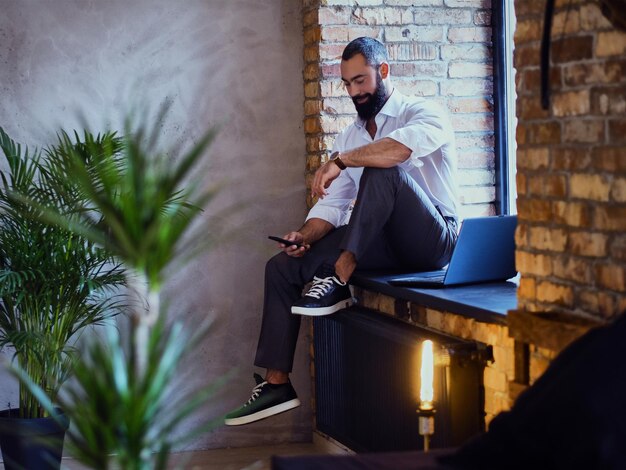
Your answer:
[0,0,311,448]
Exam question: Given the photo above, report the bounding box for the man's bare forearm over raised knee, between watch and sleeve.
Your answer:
[340,138,411,168]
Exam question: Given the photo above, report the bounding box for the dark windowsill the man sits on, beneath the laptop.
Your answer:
[350,272,517,324]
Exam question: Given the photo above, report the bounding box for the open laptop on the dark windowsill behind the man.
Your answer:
[387,215,517,288]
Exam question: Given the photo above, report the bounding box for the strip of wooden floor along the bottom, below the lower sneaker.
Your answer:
[0,439,349,470]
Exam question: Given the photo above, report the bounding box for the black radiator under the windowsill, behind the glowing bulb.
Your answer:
[313,307,489,452]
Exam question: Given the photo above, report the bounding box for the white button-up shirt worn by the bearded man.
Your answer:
[307,90,458,227]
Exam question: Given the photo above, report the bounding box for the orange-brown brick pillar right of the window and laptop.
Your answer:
[515,0,626,320]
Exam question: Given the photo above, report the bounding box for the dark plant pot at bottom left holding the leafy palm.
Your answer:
[0,409,69,470]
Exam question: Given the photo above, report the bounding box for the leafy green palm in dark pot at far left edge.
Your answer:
[0,128,125,469]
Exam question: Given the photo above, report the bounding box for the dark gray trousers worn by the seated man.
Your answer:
[254,167,457,372]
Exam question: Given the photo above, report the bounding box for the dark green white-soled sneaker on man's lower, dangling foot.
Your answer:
[224,374,300,426]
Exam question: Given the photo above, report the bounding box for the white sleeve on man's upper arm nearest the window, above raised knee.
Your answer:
[387,102,454,167]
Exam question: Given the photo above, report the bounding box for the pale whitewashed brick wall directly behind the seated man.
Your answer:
[303,0,495,217]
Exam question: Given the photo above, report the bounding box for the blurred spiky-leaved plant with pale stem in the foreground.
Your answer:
[11,110,227,469]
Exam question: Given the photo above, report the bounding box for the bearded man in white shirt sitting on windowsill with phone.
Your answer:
[225,37,458,425]
